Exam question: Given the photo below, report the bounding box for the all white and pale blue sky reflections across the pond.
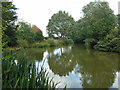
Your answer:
[36,47,120,88]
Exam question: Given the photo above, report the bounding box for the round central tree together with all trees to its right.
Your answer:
[47,1,120,52]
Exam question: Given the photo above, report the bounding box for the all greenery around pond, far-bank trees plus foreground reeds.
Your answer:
[2,1,120,89]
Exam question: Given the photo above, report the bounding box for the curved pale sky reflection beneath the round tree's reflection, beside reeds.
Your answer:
[36,59,82,88]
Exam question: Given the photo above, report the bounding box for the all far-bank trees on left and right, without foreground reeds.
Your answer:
[2,1,120,52]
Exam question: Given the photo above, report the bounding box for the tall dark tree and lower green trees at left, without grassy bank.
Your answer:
[2,2,44,47]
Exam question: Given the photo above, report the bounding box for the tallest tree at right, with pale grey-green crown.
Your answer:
[82,1,116,40]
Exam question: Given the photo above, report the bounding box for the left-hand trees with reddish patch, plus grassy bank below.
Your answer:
[2,2,73,48]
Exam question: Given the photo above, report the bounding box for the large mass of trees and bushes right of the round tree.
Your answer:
[72,1,119,51]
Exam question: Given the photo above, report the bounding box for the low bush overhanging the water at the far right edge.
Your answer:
[94,28,120,52]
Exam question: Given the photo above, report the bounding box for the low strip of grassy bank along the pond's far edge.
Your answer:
[13,38,74,50]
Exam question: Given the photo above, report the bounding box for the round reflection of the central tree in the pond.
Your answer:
[48,47,76,76]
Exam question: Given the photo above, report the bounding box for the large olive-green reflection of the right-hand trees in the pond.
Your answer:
[72,46,118,88]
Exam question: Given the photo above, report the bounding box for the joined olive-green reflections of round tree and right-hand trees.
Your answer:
[48,45,118,88]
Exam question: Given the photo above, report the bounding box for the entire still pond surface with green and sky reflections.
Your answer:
[19,45,120,88]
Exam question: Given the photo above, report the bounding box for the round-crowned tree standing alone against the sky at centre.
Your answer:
[47,11,75,38]
